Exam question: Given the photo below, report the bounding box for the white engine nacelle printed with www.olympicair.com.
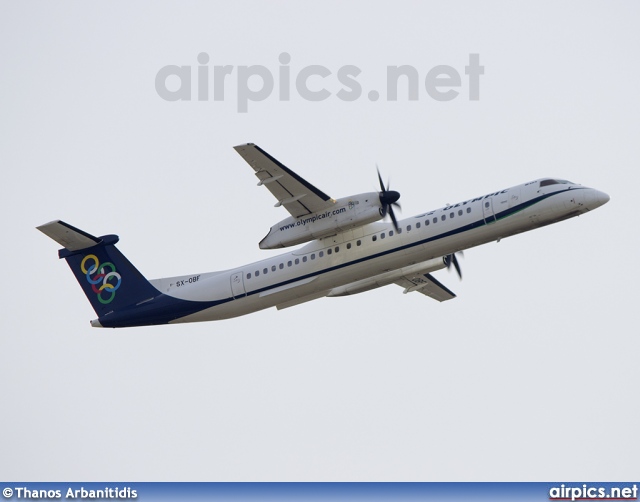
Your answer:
[260,192,382,249]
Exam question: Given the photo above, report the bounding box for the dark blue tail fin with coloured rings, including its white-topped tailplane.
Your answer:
[37,220,158,317]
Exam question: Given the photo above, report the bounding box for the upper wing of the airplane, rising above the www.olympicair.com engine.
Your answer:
[234,143,335,218]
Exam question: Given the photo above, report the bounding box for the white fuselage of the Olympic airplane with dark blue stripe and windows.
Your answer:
[150,180,609,322]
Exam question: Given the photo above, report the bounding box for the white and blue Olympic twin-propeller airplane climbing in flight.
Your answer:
[37,143,609,328]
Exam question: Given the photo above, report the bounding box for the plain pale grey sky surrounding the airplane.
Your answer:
[0,1,640,481]
